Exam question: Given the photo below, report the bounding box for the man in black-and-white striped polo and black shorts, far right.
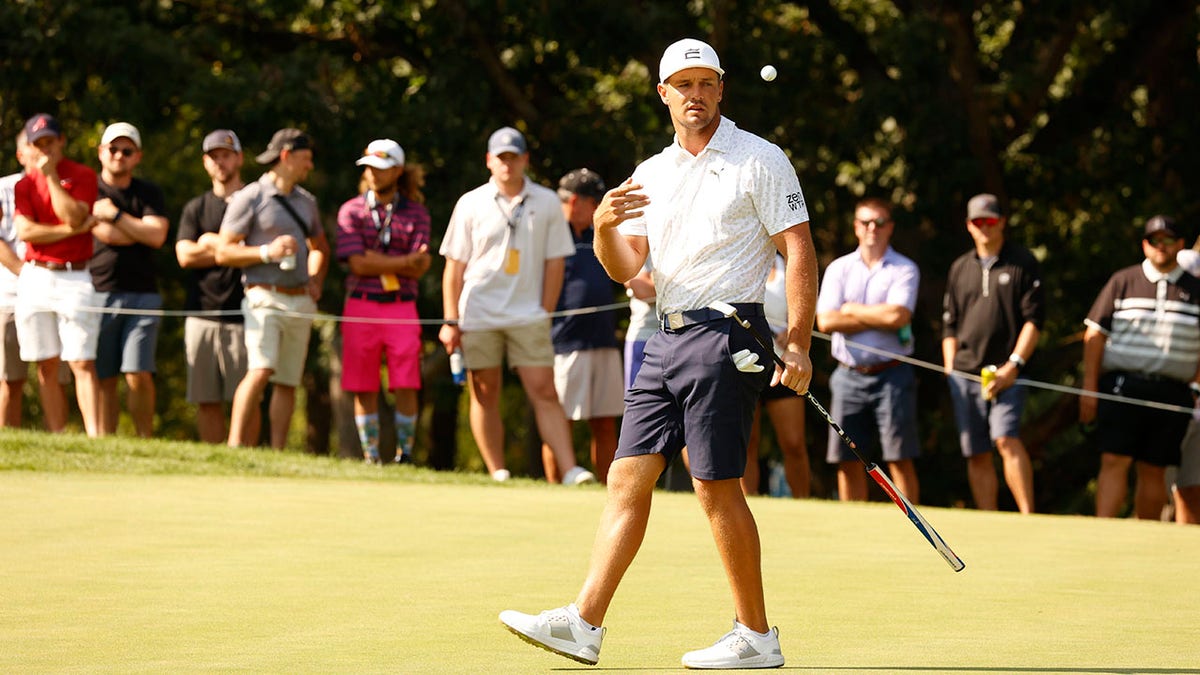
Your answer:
[1079,216,1200,520]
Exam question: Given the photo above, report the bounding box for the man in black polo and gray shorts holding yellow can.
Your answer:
[942,195,1043,513]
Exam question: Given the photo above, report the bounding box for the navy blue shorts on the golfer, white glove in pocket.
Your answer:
[616,316,774,480]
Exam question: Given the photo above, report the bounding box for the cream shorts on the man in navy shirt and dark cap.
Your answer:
[554,347,625,419]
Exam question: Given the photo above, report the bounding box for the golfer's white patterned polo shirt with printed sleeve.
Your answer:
[619,117,809,315]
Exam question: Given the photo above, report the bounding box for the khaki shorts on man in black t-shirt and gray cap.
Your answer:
[184,316,246,404]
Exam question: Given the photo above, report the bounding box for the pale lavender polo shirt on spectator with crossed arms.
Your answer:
[817,246,920,366]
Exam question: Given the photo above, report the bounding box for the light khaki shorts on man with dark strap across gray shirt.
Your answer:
[241,288,317,387]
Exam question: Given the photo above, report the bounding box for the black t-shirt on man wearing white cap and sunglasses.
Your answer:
[89,178,167,293]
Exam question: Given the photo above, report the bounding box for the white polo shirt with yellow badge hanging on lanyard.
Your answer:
[439,178,575,330]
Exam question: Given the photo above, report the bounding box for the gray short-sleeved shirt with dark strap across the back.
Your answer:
[221,174,320,287]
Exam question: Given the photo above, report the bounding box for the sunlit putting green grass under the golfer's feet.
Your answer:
[0,432,1200,674]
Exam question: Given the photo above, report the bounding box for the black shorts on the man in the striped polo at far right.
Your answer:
[1096,372,1193,466]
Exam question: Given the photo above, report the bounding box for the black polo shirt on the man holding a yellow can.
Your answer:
[942,241,1044,372]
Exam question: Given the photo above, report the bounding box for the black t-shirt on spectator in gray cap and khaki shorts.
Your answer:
[175,190,242,323]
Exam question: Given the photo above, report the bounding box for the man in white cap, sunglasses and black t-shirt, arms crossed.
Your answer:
[91,121,170,438]
